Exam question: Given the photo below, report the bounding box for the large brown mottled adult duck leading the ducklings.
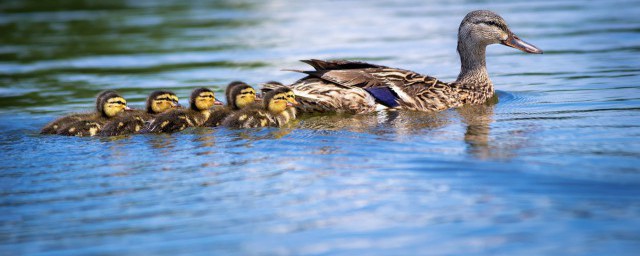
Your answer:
[263,10,542,114]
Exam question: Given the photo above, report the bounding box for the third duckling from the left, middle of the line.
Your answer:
[142,88,222,133]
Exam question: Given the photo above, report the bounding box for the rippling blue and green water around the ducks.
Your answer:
[0,0,640,255]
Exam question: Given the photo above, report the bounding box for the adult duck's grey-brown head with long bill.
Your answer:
[458,10,542,55]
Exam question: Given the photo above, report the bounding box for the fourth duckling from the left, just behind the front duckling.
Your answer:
[204,81,256,127]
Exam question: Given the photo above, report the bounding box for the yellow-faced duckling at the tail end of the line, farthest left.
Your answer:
[56,91,129,136]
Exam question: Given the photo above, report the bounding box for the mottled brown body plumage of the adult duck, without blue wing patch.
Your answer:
[284,60,480,114]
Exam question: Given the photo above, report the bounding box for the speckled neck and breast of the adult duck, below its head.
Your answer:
[456,42,494,104]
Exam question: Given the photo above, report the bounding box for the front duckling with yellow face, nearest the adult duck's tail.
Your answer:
[222,87,297,128]
